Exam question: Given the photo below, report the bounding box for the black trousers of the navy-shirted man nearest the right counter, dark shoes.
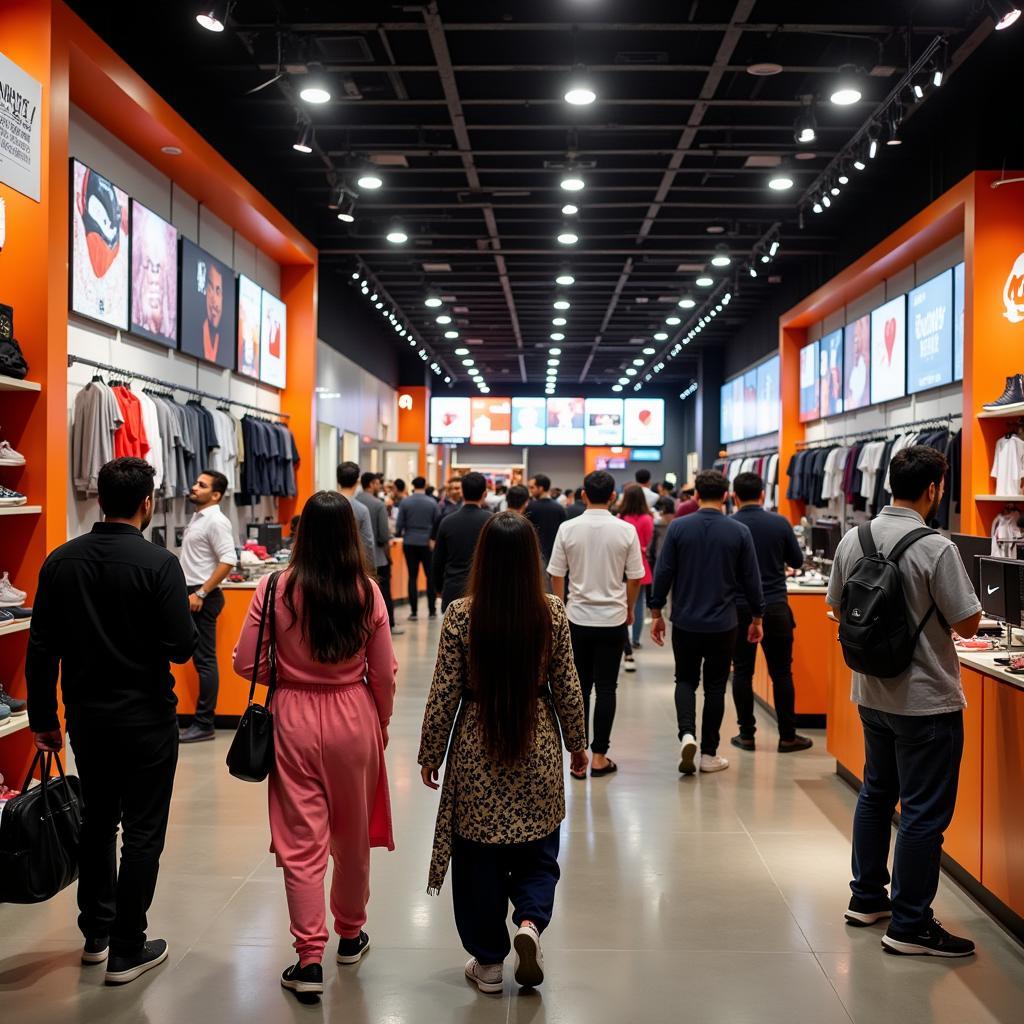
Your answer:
[732,601,797,739]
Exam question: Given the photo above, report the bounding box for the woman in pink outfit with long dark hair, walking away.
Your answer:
[234,490,398,1001]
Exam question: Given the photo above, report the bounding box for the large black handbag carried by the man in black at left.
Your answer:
[0,751,83,903]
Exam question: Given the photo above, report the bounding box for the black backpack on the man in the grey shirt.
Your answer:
[839,522,935,679]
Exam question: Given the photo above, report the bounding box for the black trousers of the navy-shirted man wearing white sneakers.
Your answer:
[672,626,736,757]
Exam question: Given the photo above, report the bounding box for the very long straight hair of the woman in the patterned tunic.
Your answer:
[469,512,551,765]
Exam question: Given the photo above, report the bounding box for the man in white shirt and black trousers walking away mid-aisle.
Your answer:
[548,470,644,778]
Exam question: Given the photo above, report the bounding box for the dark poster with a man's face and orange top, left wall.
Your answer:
[178,239,236,370]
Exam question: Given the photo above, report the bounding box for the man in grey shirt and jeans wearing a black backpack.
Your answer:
[827,445,981,956]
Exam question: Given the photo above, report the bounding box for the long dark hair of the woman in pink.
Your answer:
[284,490,374,665]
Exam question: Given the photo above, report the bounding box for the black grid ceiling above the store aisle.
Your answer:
[71,0,1024,390]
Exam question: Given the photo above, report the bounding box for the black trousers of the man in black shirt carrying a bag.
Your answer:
[68,720,178,953]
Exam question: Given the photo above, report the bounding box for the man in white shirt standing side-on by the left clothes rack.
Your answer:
[179,470,238,743]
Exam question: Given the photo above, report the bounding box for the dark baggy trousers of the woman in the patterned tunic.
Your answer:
[452,828,560,964]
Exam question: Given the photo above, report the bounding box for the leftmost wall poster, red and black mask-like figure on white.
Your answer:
[71,160,128,331]
